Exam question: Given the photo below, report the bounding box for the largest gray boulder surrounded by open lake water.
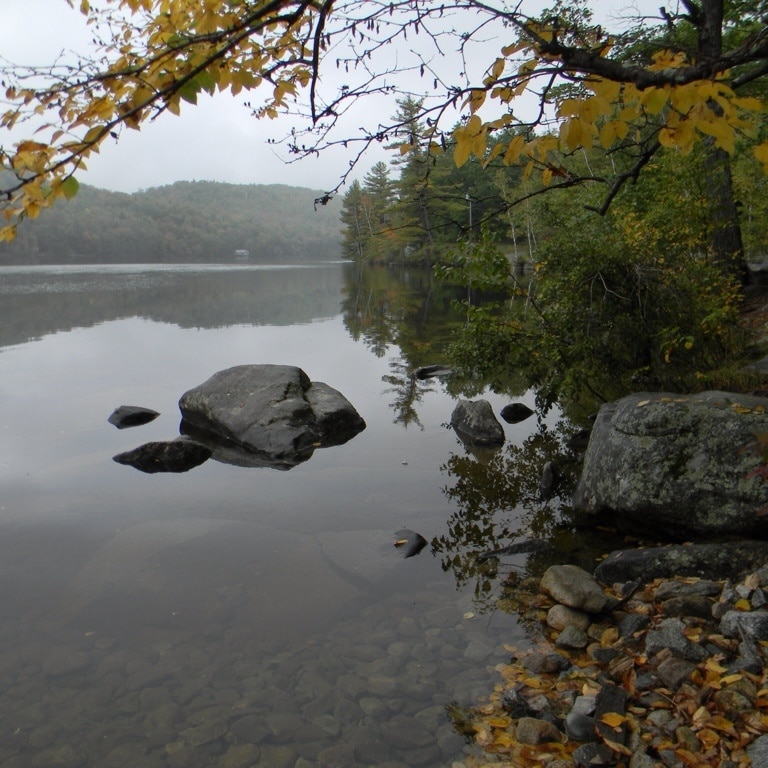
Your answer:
[179,365,365,469]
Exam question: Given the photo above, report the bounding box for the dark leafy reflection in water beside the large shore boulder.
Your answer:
[431,420,578,607]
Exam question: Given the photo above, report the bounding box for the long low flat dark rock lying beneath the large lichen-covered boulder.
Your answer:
[595,540,768,584]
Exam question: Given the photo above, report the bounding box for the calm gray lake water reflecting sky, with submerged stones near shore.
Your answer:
[0,264,580,768]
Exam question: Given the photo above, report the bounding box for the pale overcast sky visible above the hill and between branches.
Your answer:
[0,0,660,192]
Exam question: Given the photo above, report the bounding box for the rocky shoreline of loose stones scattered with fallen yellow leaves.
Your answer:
[453,565,768,768]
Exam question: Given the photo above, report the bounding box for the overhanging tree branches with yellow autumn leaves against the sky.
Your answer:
[0,0,768,240]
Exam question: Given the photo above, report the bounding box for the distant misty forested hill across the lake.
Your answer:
[0,181,341,265]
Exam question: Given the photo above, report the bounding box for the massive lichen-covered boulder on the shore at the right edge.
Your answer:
[574,392,768,536]
